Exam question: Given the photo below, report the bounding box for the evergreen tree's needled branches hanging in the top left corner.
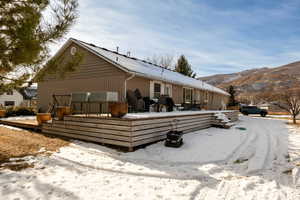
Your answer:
[0,0,78,91]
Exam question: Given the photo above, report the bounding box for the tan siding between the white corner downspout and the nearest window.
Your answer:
[127,77,150,97]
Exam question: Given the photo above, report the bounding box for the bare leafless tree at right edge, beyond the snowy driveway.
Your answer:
[273,90,300,124]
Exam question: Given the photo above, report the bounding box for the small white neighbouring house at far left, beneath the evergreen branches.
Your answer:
[0,90,24,106]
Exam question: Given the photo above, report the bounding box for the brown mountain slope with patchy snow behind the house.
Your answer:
[199,61,300,101]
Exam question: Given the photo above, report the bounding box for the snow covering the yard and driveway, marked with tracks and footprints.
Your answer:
[0,117,300,200]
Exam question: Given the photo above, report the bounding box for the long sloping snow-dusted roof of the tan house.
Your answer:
[68,38,229,95]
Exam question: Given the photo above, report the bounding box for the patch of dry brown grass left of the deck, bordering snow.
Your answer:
[0,127,69,169]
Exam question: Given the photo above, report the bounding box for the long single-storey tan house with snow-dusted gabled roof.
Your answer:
[38,38,229,111]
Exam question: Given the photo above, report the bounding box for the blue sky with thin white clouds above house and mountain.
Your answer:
[52,0,300,76]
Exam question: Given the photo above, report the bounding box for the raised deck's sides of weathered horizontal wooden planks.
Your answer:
[42,111,238,150]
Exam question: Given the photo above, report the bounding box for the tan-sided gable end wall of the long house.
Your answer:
[38,41,126,111]
